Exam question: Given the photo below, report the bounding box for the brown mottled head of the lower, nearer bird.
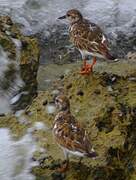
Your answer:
[55,95,70,111]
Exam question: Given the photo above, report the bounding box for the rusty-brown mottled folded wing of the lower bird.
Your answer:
[54,115,91,153]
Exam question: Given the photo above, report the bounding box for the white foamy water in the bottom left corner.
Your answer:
[0,129,36,180]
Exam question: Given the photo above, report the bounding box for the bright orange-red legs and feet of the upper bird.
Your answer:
[80,57,96,75]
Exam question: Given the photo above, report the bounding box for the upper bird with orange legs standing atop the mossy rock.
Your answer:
[58,9,115,74]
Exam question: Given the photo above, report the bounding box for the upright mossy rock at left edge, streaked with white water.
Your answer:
[0,16,39,110]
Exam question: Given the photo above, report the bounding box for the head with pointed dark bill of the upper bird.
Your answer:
[58,9,83,24]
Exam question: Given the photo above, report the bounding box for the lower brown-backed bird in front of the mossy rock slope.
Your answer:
[53,95,97,171]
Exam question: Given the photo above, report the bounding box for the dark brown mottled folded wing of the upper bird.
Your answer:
[70,19,109,54]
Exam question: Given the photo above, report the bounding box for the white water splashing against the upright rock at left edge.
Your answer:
[0,46,24,114]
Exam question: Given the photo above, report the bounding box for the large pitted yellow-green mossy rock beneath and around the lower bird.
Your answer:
[29,62,136,180]
